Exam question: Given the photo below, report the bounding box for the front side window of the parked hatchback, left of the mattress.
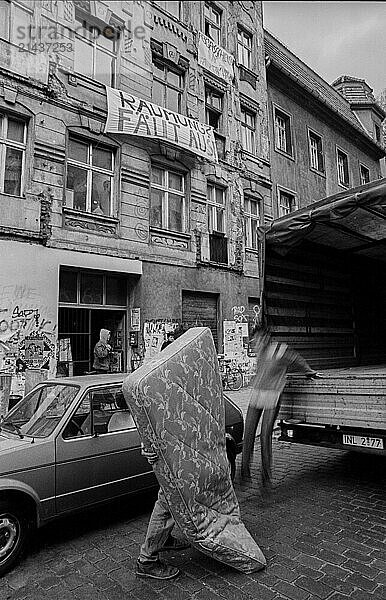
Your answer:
[63,387,135,439]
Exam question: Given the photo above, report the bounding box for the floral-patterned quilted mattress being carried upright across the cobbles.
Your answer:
[123,327,266,573]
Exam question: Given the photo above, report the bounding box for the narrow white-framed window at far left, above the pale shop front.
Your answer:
[0,114,27,196]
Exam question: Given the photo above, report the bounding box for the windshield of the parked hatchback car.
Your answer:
[0,383,79,437]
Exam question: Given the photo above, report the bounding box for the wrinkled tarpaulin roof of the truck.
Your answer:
[264,178,386,262]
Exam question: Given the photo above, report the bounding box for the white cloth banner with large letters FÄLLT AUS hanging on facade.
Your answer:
[105,86,218,162]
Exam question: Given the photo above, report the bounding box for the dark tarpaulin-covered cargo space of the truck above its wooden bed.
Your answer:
[262,179,386,369]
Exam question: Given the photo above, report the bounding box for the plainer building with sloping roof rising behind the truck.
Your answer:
[264,31,385,218]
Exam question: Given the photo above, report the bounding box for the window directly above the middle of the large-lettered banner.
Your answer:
[152,60,184,113]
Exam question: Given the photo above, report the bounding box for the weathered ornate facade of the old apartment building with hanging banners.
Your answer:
[0,0,273,384]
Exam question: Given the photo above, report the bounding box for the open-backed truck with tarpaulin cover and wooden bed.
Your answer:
[262,179,386,455]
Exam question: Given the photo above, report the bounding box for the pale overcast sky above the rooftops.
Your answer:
[263,2,386,97]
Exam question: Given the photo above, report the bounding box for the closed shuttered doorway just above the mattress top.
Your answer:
[182,291,218,348]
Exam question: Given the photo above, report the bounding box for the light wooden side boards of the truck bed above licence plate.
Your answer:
[280,364,386,430]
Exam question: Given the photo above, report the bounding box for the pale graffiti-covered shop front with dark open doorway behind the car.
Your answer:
[0,240,142,406]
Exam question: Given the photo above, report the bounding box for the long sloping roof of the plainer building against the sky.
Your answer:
[264,30,382,152]
